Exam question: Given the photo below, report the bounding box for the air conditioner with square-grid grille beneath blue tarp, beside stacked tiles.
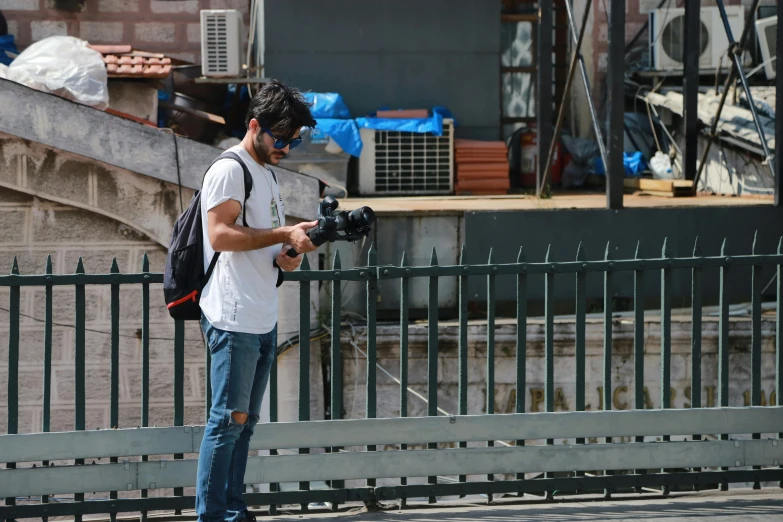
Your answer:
[359,118,454,195]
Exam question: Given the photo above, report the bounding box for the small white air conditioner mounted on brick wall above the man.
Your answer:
[201,9,244,77]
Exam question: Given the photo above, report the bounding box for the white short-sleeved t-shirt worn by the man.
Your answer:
[201,145,285,334]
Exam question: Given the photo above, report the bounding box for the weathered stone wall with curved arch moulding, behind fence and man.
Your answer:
[0,135,323,433]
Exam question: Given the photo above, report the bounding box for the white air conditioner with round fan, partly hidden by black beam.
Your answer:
[648,6,745,71]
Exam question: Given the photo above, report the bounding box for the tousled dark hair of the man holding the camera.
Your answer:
[245,80,316,138]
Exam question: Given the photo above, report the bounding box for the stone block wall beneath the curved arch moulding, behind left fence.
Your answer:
[0,185,204,433]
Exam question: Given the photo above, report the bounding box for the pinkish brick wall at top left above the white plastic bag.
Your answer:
[0,0,250,63]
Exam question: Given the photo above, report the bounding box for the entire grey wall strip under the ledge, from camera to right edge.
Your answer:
[322,203,783,318]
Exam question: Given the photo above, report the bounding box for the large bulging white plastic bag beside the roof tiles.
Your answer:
[0,36,109,110]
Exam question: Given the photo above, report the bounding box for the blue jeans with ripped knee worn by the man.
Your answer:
[196,315,277,522]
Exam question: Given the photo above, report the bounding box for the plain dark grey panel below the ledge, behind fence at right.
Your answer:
[465,202,783,313]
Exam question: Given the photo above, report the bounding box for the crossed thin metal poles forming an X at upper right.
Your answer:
[693,0,768,192]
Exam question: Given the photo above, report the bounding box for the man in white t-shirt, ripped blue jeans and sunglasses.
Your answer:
[196,81,317,522]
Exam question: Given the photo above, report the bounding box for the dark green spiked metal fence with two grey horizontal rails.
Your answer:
[0,237,783,519]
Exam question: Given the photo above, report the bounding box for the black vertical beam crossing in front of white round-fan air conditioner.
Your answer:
[682,0,701,180]
